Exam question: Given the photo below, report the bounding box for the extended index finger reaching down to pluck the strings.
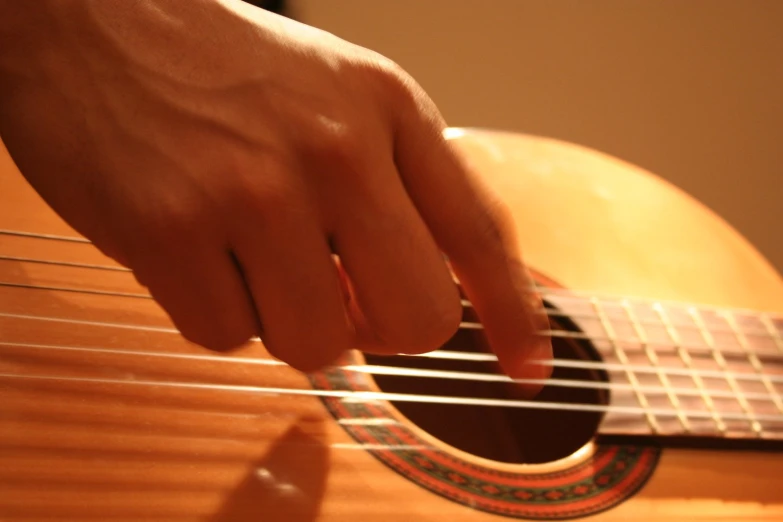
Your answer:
[395,101,552,378]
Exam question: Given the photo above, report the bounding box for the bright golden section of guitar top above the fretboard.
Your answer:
[448,129,783,312]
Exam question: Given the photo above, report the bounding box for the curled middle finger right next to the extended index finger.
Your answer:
[332,158,462,353]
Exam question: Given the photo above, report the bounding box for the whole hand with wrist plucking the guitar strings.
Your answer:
[0,0,551,378]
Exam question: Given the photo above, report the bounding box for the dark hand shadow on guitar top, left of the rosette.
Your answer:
[210,418,329,522]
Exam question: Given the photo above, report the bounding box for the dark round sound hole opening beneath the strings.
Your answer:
[365,300,609,464]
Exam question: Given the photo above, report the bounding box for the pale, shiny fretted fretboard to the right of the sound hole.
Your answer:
[545,292,783,440]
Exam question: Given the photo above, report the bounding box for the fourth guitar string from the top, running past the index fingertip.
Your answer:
[0,312,783,384]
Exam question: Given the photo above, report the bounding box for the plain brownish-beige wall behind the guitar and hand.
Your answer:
[289,0,783,271]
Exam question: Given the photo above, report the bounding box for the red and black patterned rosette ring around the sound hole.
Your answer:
[311,361,660,520]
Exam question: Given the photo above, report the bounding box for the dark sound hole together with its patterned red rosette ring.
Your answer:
[310,286,660,520]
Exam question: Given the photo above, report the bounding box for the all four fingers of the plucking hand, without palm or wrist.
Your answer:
[121,90,552,378]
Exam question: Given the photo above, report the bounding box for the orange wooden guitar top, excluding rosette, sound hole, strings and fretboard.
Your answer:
[0,131,783,522]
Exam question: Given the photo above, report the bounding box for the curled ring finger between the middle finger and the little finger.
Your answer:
[232,178,353,371]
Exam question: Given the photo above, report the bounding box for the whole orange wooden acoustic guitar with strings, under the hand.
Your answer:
[0,129,783,522]
